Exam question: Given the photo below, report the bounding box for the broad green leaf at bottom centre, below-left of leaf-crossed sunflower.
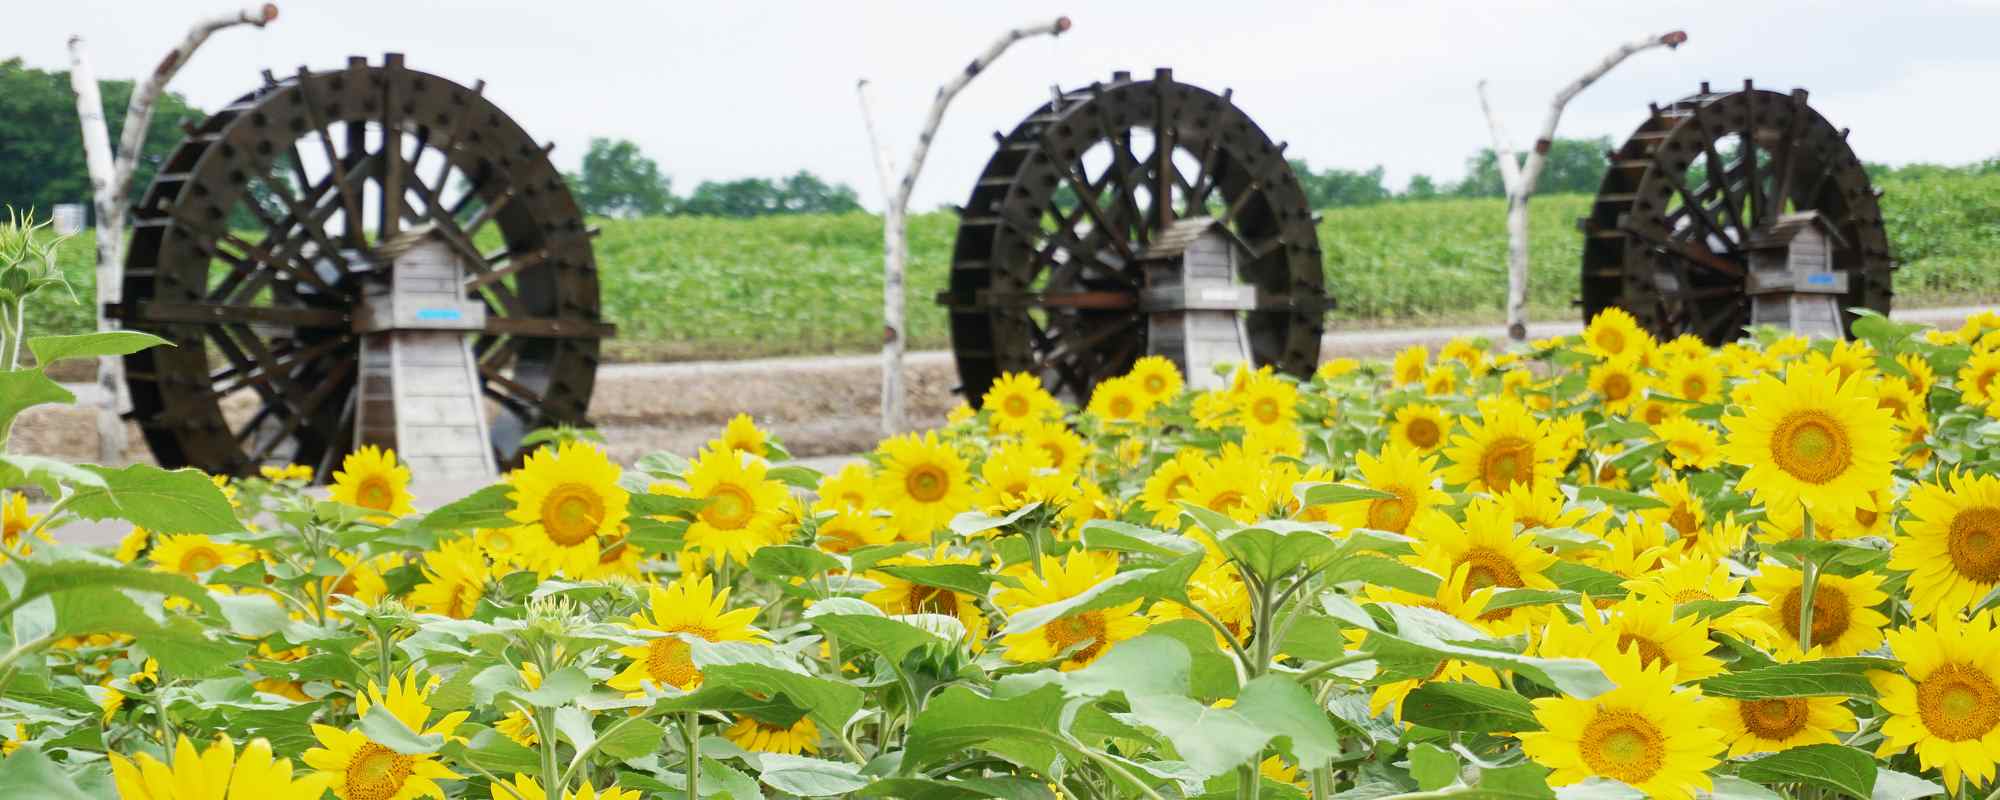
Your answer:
[902,684,1072,774]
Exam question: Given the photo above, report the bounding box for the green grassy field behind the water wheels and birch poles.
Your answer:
[34,176,2000,360]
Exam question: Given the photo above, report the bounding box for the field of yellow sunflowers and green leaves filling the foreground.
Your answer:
[0,284,2000,800]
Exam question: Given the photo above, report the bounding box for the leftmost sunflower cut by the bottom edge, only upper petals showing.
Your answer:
[111,726,328,800]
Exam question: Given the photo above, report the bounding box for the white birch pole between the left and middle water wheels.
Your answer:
[854,16,1070,436]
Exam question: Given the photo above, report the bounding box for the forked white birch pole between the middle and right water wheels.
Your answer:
[1478,30,1688,342]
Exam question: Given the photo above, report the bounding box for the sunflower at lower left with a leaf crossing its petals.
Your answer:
[300,670,472,800]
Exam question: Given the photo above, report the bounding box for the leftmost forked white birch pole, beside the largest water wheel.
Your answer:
[70,2,278,464]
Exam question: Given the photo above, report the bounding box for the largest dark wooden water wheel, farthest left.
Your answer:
[110,54,612,480]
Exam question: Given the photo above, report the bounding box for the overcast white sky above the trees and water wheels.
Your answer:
[15,0,2000,208]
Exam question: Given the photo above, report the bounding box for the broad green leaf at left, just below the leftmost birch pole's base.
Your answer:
[68,464,244,534]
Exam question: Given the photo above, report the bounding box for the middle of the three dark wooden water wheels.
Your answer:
[938,70,1330,402]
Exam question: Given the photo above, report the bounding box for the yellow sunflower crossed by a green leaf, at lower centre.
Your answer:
[994,550,1146,672]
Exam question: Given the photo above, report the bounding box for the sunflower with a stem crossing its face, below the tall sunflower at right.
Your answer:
[1750,560,1888,658]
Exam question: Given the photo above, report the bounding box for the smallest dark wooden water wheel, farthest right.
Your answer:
[1580,80,1894,344]
